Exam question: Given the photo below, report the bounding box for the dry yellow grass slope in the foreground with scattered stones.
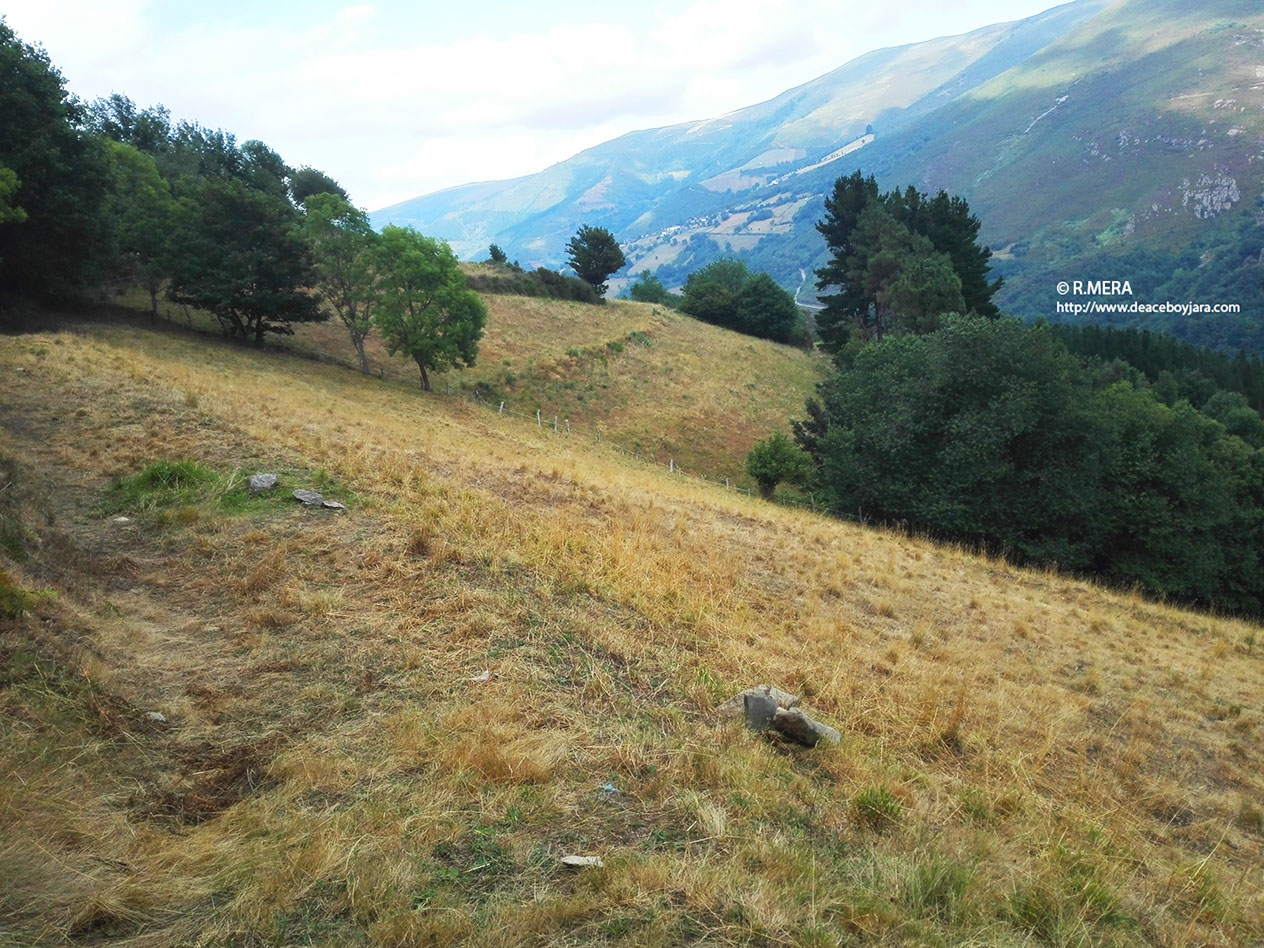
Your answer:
[0,317,1264,945]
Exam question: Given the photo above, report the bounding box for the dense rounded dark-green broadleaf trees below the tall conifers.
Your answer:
[796,316,1264,614]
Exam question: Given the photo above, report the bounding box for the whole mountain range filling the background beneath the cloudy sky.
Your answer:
[373,0,1264,349]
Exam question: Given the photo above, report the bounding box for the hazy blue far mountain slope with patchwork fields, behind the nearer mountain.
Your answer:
[373,0,1106,264]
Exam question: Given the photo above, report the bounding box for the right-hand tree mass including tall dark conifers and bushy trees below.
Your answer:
[747,173,1264,616]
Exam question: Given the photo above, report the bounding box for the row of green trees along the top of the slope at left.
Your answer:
[0,19,487,391]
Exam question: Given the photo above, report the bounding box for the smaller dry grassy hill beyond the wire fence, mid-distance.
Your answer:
[206,276,828,479]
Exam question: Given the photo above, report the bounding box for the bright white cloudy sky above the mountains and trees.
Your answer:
[7,0,1055,210]
